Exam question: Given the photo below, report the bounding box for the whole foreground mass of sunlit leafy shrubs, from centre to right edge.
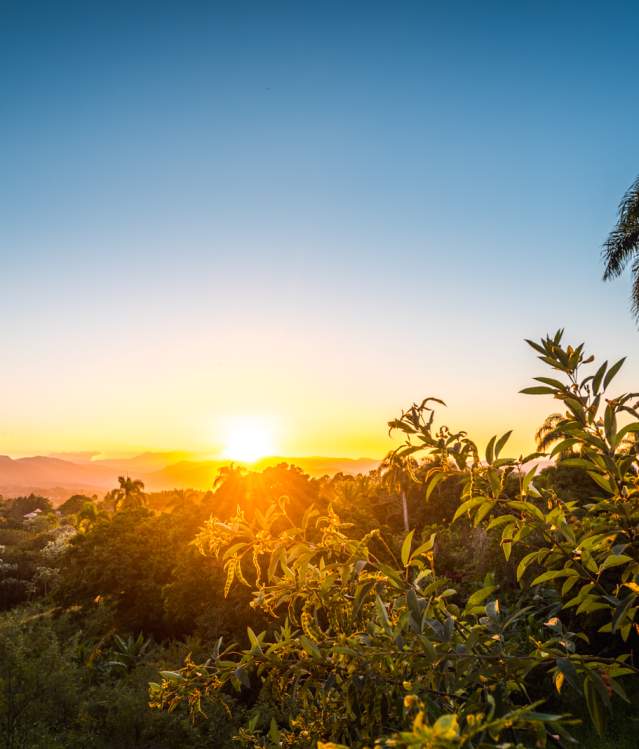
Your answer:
[151,332,639,747]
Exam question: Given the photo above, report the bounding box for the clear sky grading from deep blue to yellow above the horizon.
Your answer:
[0,0,639,457]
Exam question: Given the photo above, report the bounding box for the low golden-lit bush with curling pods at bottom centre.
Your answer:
[152,505,581,747]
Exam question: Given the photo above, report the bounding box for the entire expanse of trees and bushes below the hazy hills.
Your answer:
[0,331,639,749]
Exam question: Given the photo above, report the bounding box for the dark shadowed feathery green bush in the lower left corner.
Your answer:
[0,606,240,749]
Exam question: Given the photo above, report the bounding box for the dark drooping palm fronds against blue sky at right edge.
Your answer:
[602,177,639,321]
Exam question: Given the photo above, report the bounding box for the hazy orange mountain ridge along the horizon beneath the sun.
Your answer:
[0,452,380,499]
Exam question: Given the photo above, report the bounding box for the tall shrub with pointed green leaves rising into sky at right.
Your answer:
[390,331,639,732]
